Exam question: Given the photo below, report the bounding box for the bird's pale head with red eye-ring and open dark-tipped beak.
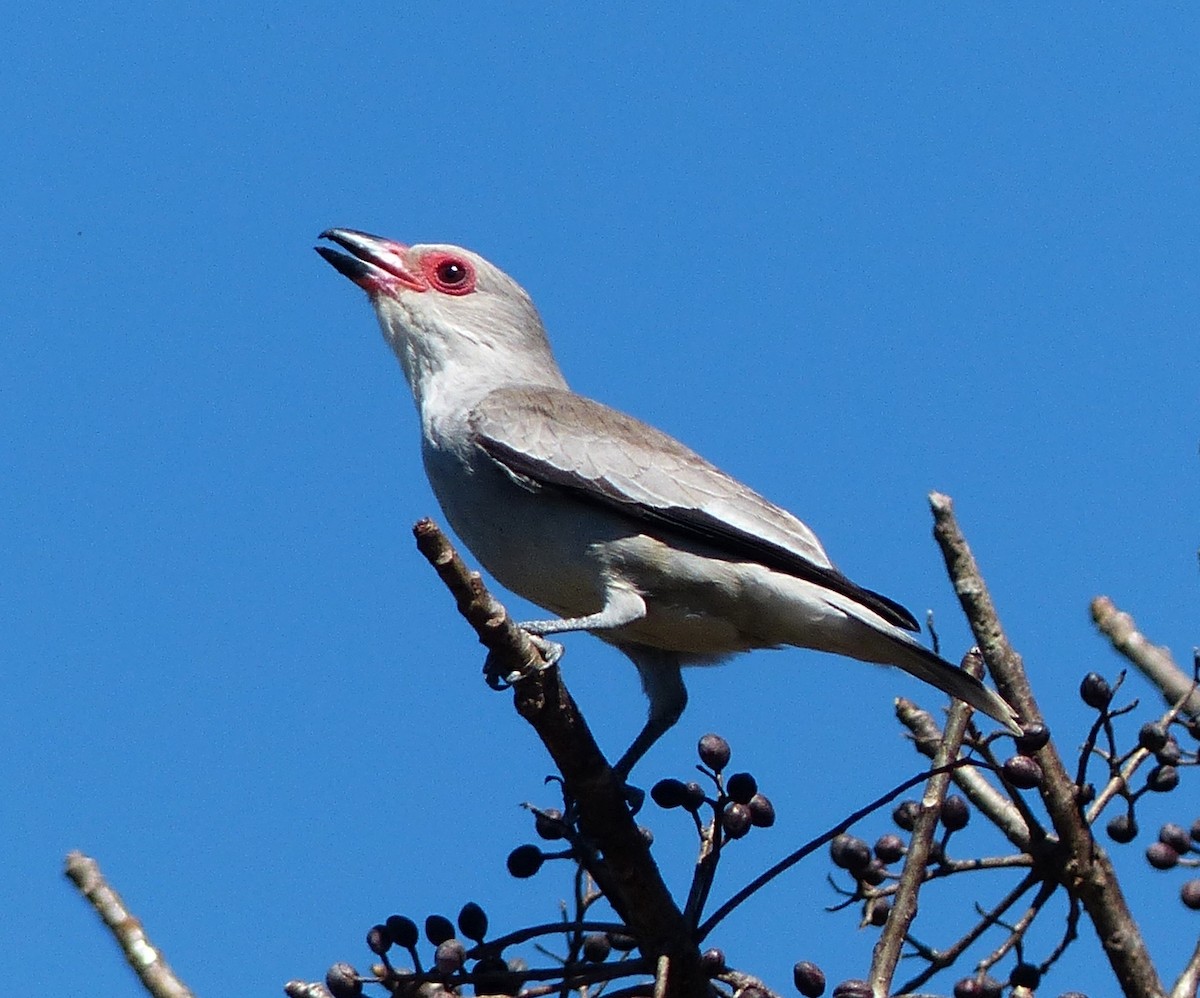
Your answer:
[316,229,562,403]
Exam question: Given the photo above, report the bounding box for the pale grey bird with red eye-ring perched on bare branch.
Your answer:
[316,229,1020,776]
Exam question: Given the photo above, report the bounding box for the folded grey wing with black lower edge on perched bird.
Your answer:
[469,385,919,631]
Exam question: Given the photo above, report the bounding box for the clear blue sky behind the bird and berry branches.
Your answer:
[0,7,1200,996]
